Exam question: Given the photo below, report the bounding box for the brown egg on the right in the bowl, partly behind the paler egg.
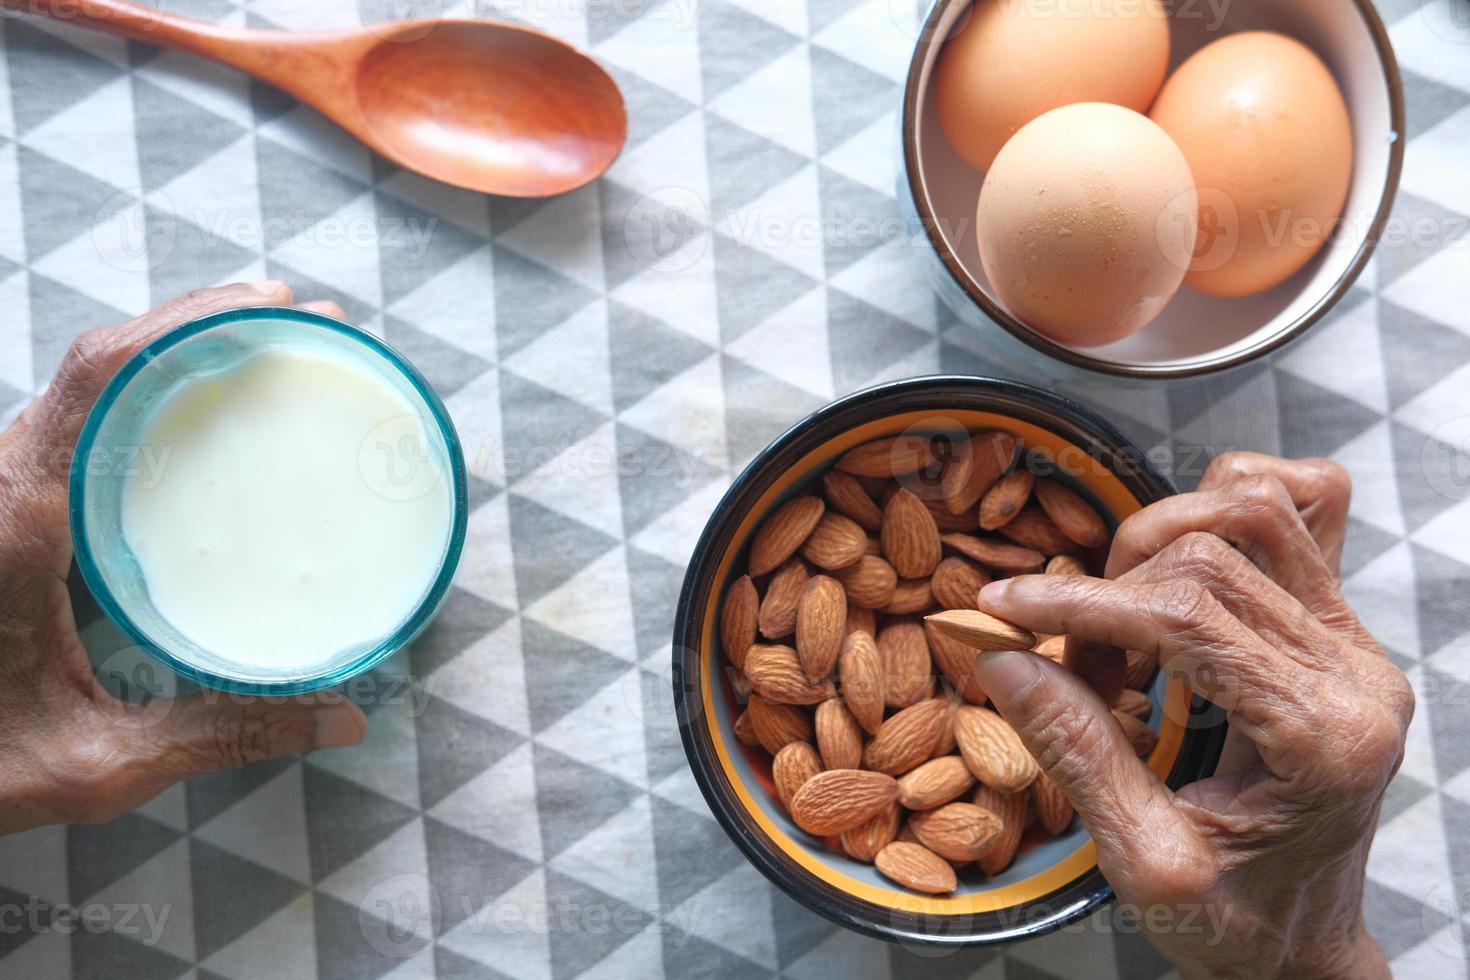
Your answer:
[1151,31,1352,297]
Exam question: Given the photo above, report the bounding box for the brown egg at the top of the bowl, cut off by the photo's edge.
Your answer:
[933,0,1169,170]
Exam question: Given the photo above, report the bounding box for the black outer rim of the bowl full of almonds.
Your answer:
[673,375,1226,946]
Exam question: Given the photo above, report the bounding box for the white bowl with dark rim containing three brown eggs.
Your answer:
[898,0,1405,379]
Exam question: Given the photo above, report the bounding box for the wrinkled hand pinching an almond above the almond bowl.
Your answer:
[978,454,1414,980]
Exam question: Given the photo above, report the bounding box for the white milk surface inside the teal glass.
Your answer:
[122,350,453,673]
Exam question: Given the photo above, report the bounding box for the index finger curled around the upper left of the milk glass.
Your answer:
[28,281,291,470]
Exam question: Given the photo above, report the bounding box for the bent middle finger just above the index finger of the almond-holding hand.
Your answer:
[1105,476,1351,637]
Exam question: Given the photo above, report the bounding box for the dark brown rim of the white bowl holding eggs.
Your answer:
[900,0,1408,379]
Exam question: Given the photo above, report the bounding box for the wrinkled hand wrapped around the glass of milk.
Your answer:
[0,282,368,833]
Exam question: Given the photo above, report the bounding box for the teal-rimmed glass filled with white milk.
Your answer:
[71,307,469,695]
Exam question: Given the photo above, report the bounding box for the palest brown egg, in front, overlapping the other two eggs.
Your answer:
[976,103,1198,347]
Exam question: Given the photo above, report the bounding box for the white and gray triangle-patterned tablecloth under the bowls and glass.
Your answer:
[0,0,1470,980]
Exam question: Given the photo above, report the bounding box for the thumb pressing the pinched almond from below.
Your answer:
[975,652,1195,892]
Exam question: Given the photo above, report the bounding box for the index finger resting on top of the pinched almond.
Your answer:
[979,574,1319,743]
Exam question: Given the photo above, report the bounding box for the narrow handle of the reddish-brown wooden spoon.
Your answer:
[0,0,359,96]
